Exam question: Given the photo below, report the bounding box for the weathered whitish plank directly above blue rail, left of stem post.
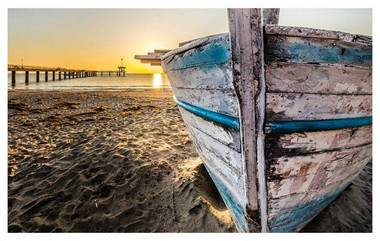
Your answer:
[172,85,239,117]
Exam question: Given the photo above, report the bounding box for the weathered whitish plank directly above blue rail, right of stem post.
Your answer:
[266,93,372,121]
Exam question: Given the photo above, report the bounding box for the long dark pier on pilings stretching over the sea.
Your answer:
[8,64,126,86]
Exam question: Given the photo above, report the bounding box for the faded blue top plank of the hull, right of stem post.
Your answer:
[266,39,372,65]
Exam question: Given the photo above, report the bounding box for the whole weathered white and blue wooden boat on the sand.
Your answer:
[161,9,372,232]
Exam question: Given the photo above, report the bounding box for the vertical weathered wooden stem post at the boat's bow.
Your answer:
[228,8,267,232]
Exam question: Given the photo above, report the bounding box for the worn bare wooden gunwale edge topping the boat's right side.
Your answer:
[265,25,372,47]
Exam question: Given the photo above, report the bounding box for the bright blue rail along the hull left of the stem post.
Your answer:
[175,98,239,129]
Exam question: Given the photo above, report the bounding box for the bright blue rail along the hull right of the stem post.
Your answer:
[266,116,372,134]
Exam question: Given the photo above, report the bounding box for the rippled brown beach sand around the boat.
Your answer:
[8,89,372,232]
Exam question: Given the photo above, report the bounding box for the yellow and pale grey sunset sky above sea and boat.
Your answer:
[8,9,372,73]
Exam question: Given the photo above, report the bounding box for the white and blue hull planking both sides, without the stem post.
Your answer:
[162,26,372,232]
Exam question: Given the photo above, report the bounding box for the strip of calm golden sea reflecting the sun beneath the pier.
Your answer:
[8,72,170,91]
